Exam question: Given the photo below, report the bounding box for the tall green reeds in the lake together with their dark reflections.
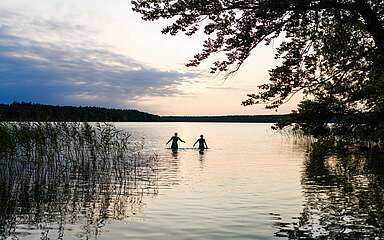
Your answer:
[0,123,158,239]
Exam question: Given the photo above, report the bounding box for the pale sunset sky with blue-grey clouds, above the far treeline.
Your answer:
[0,0,299,115]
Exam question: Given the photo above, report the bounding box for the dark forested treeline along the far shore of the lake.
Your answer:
[0,102,286,123]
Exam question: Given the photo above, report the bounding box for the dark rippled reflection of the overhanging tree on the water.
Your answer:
[275,145,384,239]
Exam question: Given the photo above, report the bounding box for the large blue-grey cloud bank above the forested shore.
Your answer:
[0,11,198,107]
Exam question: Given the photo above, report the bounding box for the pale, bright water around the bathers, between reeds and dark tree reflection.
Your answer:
[101,123,305,239]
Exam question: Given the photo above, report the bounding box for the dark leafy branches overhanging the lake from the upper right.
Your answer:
[132,0,384,144]
